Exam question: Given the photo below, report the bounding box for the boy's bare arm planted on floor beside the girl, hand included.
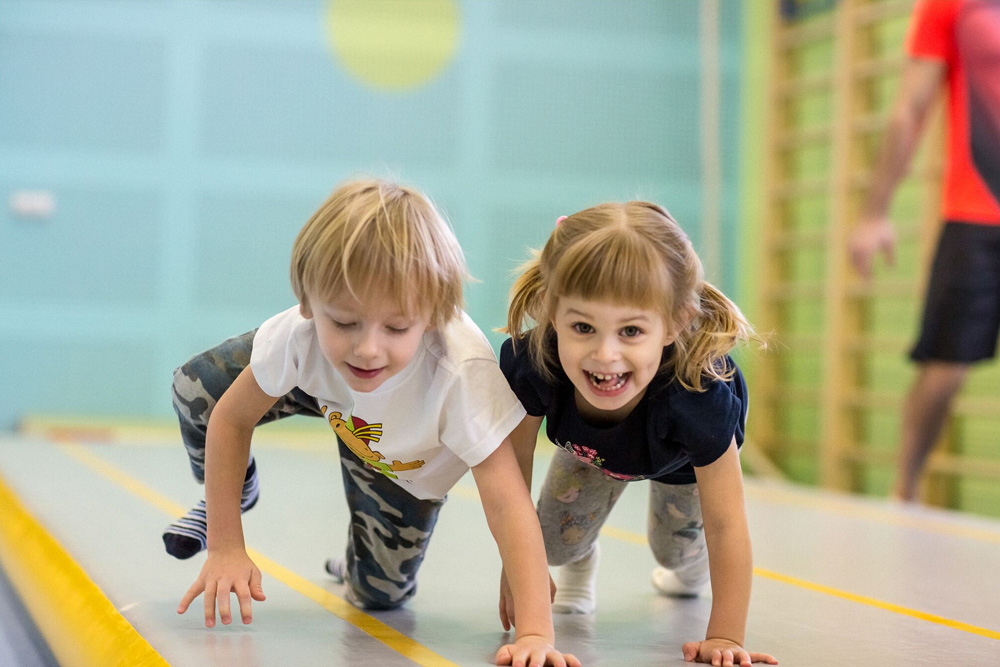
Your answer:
[472,438,580,667]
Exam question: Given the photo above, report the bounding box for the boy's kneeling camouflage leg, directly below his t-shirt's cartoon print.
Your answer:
[326,438,445,609]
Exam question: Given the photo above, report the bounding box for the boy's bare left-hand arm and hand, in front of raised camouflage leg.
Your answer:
[177,366,277,627]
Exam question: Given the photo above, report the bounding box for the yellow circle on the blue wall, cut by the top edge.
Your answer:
[326,0,458,90]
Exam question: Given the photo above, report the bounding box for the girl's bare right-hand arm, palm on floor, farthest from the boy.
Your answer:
[683,439,778,665]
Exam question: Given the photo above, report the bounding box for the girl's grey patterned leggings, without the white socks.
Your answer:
[538,449,708,570]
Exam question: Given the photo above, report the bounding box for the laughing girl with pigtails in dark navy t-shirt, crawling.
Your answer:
[500,202,777,665]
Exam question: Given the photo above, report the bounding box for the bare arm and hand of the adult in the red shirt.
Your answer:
[850,57,946,278]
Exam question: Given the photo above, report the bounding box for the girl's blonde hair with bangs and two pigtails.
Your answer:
[505,201,755,391]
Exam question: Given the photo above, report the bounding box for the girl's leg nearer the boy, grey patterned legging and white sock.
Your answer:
[538,449,627,614]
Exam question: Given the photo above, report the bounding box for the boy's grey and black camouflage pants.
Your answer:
[173,331,444,609]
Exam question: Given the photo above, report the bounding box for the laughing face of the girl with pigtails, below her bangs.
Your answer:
[552,297,674,421]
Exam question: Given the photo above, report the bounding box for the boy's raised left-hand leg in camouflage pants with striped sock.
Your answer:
[163,331,322,558]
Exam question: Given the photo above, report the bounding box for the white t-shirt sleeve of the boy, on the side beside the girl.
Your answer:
[441,359,524,468]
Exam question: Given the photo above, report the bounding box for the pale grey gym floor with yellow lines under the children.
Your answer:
[0,426,1000,667]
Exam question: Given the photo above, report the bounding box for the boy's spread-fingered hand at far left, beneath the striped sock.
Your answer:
[177,549,264,628]
